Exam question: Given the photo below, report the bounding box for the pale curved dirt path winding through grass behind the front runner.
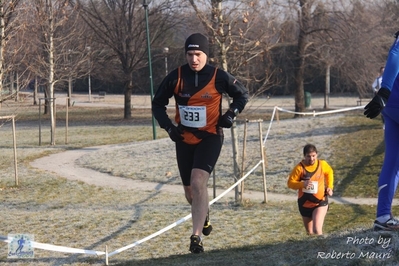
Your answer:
[30,146,399,205]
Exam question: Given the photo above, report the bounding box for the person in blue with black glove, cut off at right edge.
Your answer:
[364,31,399,231]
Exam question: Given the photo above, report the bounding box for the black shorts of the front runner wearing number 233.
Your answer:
[176,135,223,186]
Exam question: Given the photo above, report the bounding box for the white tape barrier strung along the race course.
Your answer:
[0,106,364,259]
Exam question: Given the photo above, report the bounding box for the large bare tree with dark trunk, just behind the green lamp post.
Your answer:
[77,0,186,119]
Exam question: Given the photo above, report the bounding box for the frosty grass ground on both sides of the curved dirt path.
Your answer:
[0,98,399,266]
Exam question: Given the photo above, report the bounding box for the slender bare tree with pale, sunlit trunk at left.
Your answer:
[23,0,86,145]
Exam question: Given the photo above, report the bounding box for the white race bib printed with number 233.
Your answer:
[179,105,206,128]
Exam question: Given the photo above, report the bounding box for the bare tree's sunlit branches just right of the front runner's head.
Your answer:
[189,0,281,97]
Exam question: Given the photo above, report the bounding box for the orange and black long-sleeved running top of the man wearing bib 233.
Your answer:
[152,64,248,144]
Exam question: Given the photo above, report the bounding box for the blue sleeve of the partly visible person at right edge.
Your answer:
[381,38,399,91]
